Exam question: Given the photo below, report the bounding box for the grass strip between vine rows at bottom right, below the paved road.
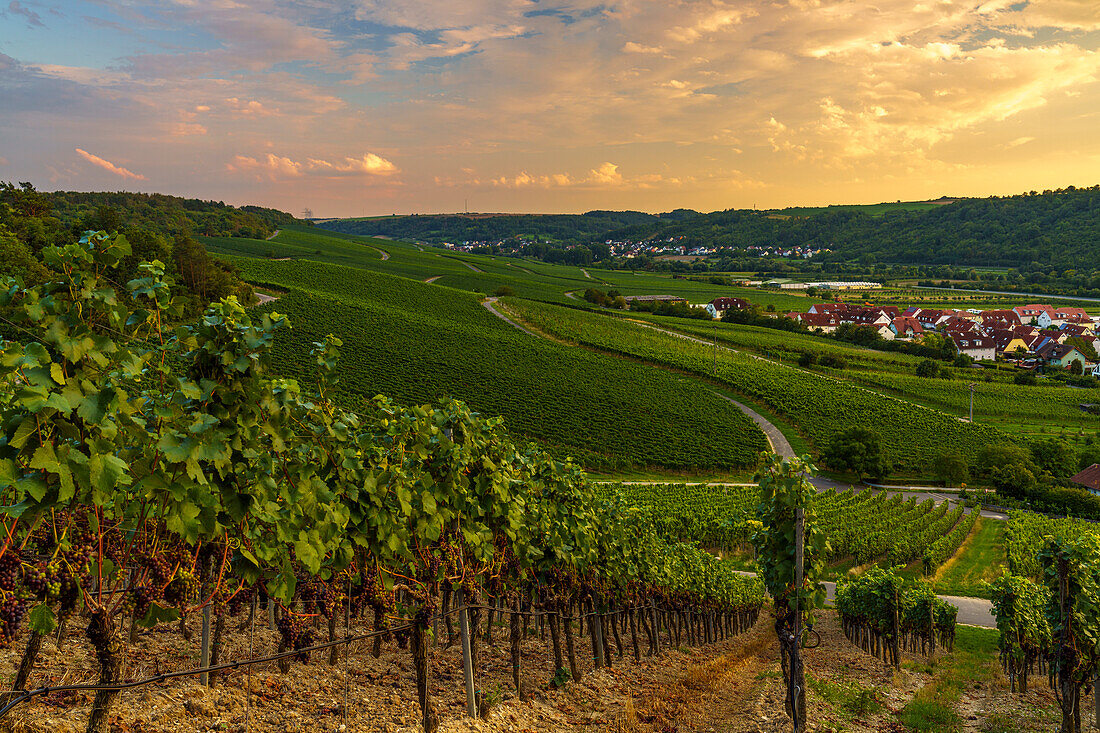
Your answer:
[898,626,1000,733]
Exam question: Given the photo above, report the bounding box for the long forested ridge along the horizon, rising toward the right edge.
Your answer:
[320,186,1100,270]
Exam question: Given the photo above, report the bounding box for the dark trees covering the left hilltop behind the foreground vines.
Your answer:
[0,183,296,316]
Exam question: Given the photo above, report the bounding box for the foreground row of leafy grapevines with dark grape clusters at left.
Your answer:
[0,232,763,733]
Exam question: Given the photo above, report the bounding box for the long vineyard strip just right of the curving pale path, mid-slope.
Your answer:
[499,300,1004,472]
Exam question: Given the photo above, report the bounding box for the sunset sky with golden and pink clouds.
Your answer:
[0,0,1100,217]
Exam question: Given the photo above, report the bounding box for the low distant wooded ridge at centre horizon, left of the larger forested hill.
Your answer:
[317,209,700,244]
